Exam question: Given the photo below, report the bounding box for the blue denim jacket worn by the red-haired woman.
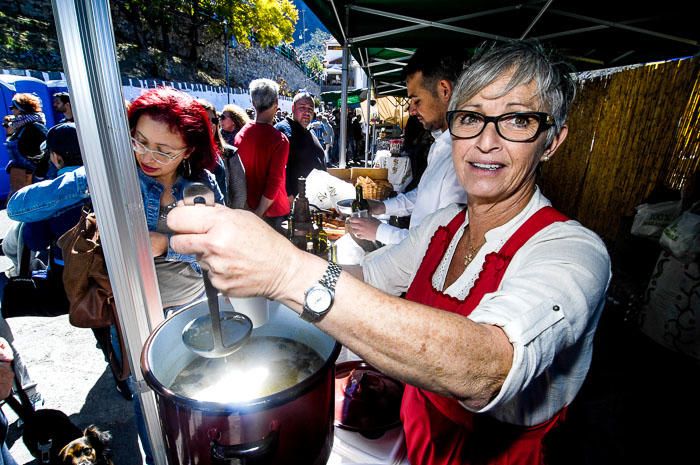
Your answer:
[7,166,224,271]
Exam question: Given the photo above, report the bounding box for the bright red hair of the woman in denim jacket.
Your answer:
[128,87,219,179]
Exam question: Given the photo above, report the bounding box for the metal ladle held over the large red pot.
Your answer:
[182,183,253,358]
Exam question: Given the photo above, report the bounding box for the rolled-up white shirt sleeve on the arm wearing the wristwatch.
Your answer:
[469,222,611,424]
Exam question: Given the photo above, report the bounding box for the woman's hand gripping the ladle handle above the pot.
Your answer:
[168,204,303,299]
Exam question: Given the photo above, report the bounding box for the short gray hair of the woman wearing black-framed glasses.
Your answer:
[448,41,576,147]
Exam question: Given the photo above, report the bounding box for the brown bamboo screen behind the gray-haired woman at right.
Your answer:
[539,59,700,241]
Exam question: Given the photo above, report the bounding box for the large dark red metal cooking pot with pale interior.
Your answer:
[141,297,340,465]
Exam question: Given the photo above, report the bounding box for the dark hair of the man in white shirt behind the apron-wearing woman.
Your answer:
[403,48,466,92]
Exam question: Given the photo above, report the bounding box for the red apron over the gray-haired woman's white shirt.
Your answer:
[401,207,568,465]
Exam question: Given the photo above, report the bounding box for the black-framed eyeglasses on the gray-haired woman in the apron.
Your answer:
[447,110,554,142]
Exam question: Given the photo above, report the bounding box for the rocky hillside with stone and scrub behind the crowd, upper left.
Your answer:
[0,0,319,93]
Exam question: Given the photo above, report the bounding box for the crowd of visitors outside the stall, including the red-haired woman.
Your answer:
[0,73,378,463]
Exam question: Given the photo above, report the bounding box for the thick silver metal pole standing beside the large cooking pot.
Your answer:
[52,0,167,465]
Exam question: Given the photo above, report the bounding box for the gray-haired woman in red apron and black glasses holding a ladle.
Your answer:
[168,42,611,465]
